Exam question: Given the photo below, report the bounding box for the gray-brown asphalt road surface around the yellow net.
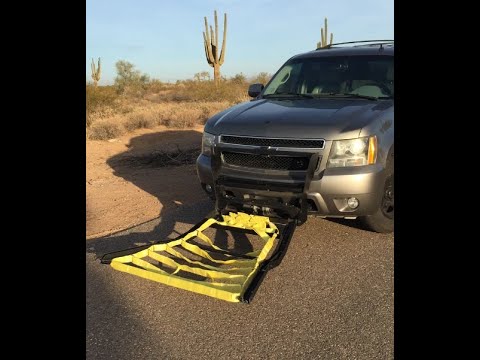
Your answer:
[86,200,394,360]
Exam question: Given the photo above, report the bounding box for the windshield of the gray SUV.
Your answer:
[263,55,394,98]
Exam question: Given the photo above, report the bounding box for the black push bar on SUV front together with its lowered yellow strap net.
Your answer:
[101,153,319,303]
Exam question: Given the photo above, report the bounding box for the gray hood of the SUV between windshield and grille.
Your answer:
[205,98,393,140]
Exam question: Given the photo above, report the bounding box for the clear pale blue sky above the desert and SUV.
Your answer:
[86,0,394,85]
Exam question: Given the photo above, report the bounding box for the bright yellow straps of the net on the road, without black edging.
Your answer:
[111,213,279,302]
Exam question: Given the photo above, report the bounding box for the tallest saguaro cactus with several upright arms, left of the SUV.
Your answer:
[203,10,227,86]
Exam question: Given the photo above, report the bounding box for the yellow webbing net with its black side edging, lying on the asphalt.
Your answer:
[101,212,296,303]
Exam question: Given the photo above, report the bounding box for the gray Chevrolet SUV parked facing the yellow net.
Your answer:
[197,40,394,232]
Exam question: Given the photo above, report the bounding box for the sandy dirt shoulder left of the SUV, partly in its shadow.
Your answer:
[86,126,205,239]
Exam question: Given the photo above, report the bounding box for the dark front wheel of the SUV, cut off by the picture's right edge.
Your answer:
[362,173,394,233]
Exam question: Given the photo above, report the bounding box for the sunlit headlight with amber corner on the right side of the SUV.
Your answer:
[327,136,377,167]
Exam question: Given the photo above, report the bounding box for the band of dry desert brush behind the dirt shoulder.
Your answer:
[87,74,260,140]
